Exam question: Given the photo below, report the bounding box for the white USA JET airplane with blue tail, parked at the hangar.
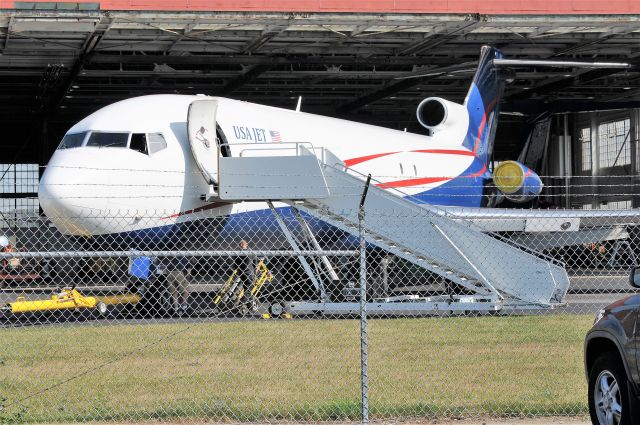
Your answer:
[39,47,636,248]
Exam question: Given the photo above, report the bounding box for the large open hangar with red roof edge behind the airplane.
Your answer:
[0,0,640,224]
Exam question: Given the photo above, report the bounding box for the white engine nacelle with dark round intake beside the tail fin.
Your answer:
[416,97,469,134]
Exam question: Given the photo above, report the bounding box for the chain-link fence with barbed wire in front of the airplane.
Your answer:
[0,184,640,423]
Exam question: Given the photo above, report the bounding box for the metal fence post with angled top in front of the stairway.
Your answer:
[358,174,371,425]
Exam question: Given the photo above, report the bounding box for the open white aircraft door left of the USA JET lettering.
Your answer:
[187,99,219,186]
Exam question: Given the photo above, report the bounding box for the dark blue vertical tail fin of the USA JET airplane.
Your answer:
[463,46,504,163]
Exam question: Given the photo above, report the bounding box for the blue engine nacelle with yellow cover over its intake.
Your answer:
[493,161,543,202]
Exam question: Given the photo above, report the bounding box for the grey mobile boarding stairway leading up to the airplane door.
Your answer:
[189,99,569,315]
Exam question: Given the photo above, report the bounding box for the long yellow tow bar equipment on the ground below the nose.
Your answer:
[2,288,140,315]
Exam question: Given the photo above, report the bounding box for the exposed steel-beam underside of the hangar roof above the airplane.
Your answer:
[0,3,640,159]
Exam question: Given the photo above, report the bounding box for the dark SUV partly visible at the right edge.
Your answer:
[584,267,640,425]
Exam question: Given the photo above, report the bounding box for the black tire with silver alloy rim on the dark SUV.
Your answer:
[589,352,632,425]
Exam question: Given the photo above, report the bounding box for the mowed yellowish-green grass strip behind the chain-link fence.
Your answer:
[0,315,593,423]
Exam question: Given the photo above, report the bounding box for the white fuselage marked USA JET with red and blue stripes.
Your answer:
[39,95,490,236]
